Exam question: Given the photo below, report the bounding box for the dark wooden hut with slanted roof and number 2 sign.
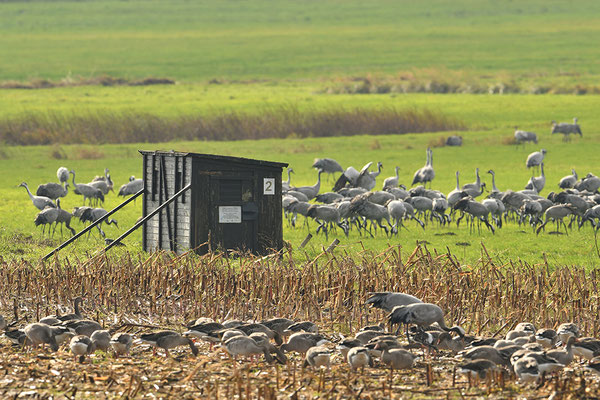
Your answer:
[140,151,287,254]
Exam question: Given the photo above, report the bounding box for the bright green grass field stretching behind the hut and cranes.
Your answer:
[0,0,600,266]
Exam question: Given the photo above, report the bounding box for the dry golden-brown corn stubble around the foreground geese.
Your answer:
[0,246,600,399]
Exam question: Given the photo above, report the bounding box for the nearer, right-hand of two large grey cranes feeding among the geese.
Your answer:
[388,303,465,342]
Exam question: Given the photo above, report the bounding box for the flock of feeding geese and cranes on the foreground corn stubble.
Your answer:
[0,292,600,382]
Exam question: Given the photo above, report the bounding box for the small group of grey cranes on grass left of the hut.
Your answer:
[19,167,143,237]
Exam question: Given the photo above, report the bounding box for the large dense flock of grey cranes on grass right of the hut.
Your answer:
[282,144,600,236]
